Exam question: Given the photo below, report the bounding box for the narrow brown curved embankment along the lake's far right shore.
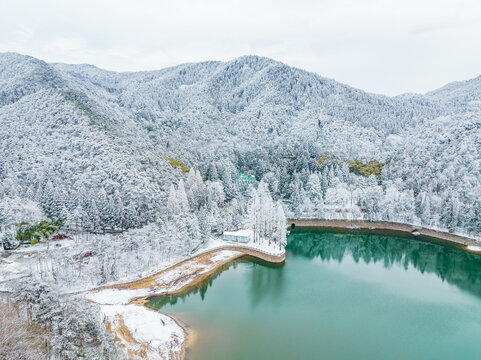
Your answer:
[287,219,481,253]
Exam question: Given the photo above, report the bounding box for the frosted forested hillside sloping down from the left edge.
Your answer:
[0,54,175,227]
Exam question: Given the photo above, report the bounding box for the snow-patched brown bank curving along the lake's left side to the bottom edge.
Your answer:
[86,244,286,359]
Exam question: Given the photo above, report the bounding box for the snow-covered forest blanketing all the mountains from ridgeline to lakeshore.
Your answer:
[0,53,481,246]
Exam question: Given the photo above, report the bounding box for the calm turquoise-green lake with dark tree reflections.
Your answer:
[148,229,481,360]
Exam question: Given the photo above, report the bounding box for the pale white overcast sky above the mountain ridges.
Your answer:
[0,0,481,95]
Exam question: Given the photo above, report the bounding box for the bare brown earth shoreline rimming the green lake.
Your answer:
[89,219,481,360]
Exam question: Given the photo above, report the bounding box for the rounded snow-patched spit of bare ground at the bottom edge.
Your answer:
[100,305,185,360]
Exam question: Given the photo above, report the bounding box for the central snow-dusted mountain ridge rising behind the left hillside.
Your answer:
[51,56,444,161]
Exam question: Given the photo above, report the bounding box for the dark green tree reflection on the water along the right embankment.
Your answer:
[287,229,481,298]
